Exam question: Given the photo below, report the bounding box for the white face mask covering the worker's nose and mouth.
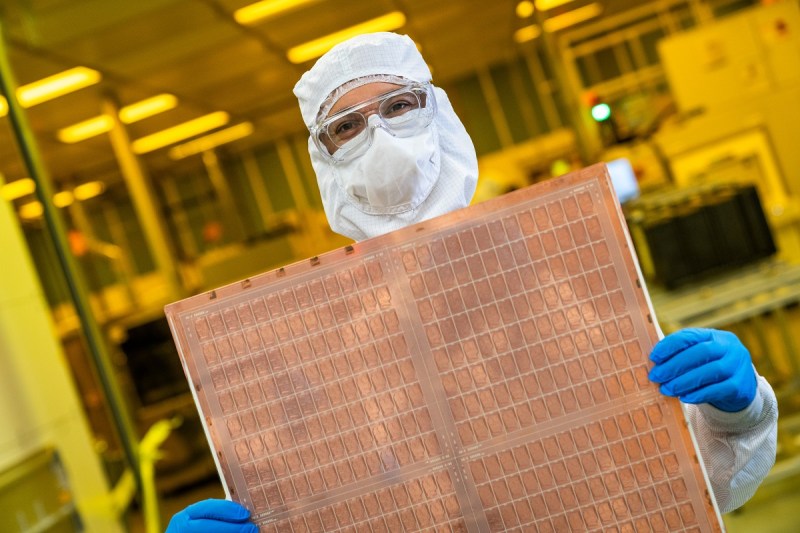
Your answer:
[333,116,441,215]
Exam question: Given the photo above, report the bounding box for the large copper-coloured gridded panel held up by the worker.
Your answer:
[167,166,721,532]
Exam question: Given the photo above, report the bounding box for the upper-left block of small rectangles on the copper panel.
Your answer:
[194,261,441,520]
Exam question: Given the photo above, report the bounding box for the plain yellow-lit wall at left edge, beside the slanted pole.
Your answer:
[0,177,123,533]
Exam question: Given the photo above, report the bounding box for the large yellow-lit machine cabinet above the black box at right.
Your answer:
[653,2,800,260]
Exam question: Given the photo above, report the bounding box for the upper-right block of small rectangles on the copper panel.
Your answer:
[403,192,649,446]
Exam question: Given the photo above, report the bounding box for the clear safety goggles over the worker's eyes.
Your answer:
[311,83,436,161]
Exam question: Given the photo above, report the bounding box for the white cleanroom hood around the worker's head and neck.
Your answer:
[294,33,478,241]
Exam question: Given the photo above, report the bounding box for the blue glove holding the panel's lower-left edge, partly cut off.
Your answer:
[166,500,258,533]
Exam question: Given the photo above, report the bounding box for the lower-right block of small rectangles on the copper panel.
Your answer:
[469,403,700,532]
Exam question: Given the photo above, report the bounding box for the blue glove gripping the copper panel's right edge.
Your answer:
[650,328,757,413]
